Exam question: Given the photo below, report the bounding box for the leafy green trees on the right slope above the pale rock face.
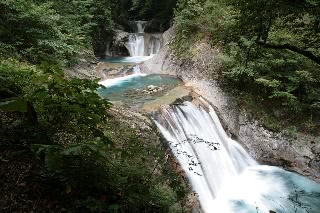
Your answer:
[174,0,320,130]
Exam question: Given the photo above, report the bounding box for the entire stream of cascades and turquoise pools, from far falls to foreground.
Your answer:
[98,23,320,213]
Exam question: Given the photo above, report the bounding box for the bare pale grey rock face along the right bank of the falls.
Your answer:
[141,27,320,182]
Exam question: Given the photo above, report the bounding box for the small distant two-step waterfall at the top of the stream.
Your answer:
[125,21,162,57]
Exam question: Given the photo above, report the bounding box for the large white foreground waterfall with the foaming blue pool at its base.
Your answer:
[155,100,320,213]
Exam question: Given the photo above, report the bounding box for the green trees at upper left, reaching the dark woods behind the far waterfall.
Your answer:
[0,0,176,59]
